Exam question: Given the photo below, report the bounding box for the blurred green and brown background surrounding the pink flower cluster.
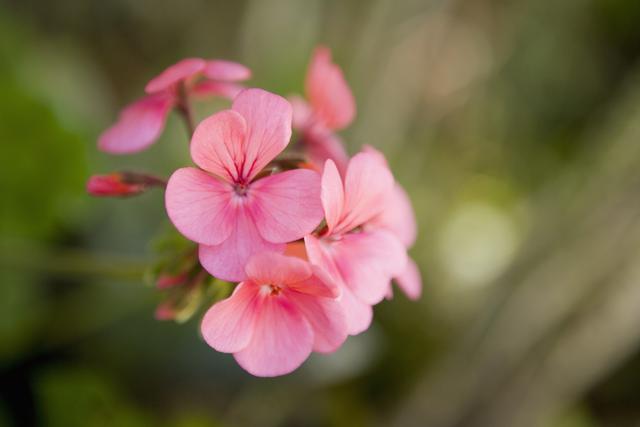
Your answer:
[0,0,640,427]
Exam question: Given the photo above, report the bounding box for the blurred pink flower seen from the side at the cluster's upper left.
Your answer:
[98,58,251,154]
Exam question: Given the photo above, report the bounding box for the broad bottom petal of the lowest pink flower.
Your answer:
[234,295,313,377]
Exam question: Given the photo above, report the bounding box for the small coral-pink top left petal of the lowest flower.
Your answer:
[245,252,312,285]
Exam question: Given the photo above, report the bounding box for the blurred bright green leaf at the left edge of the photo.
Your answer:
[0,80,86,238]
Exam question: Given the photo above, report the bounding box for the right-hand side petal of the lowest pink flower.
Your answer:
[287,292,347,353]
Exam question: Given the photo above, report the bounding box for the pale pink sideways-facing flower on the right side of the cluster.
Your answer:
[305,153,407,335]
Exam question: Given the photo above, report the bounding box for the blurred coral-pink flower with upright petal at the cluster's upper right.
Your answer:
[291,46,356,172]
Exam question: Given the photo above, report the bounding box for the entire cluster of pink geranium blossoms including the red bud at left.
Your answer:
[88,47,421,376]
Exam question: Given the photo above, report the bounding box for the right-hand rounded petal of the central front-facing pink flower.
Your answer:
[250,169,323,243]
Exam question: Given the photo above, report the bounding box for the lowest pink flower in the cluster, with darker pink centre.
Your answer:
[201,253,347,377]
